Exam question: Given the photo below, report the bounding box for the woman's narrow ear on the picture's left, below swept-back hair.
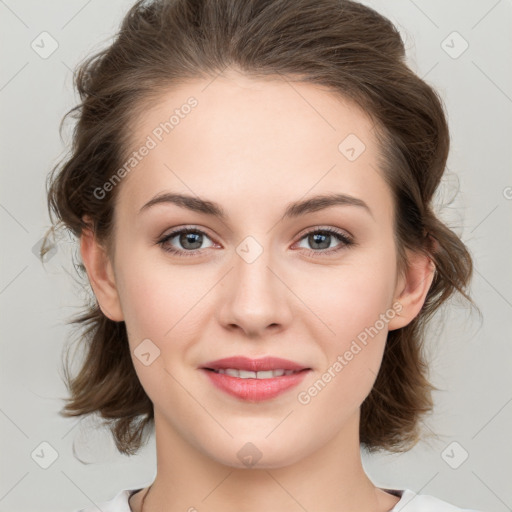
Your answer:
[80,219,124,322]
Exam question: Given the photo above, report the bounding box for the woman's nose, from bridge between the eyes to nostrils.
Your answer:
[217,241,293,338]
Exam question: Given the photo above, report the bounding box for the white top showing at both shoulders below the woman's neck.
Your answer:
[76,489,479,512]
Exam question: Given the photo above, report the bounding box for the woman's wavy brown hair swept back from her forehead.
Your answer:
[44,0,472,454]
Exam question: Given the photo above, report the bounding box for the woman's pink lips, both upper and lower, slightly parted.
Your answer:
[201,357,311,402]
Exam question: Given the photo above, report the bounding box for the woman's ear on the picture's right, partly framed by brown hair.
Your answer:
[388,252,435,331]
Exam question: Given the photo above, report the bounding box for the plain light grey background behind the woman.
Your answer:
[0,0,512,512]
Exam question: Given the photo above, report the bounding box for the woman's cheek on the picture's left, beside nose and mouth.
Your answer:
[113,251,198,409]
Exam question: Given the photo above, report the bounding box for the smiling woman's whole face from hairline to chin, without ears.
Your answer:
[103,73,408,467]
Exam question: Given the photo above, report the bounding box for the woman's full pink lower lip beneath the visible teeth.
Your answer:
[202,369,310,402]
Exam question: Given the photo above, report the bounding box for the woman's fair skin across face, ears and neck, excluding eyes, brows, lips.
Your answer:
[81,70,433,512]
